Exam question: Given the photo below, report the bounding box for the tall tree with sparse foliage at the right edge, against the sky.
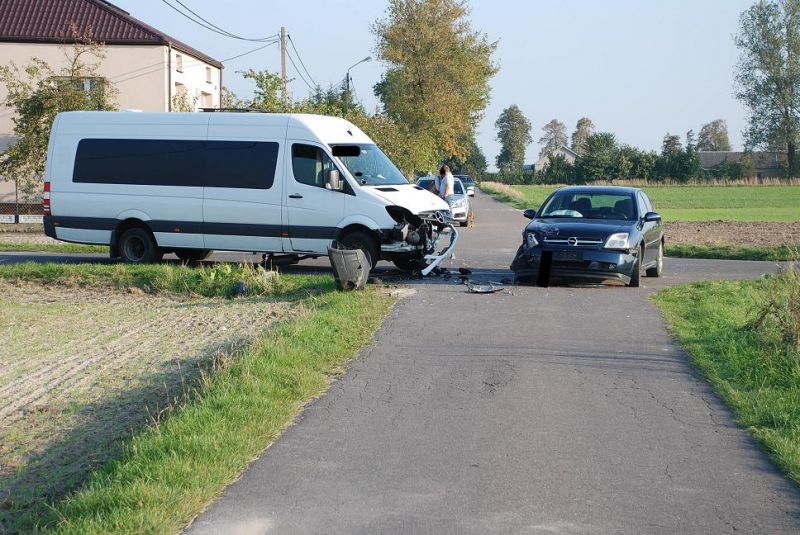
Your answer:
[734,0,800,176]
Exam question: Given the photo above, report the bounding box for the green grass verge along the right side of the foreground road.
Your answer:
[654,270,800,483]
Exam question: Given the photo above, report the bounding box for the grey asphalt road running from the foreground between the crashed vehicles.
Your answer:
[0,194,800,534]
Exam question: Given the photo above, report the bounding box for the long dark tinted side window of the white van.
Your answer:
[72,139,278,189]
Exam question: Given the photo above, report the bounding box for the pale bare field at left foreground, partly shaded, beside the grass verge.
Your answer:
[0,281,303,531]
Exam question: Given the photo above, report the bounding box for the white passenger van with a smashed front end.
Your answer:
[44,112,457,270]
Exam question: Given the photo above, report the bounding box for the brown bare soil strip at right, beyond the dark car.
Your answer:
[664,221,800,247]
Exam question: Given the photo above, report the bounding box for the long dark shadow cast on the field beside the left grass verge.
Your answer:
[0,332,250,533]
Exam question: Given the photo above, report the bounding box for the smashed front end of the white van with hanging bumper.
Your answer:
[381,211,458,277]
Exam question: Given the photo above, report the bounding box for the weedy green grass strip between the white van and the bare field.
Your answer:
[0,262,316,297]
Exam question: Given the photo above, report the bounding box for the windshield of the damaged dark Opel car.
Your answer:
[537,191,636,220]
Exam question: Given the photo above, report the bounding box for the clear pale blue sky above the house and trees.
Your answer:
[111,0,753,171]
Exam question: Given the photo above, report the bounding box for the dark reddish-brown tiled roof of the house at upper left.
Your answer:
[0,0,222,69]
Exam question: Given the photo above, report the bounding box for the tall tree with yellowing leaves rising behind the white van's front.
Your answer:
[372,0,498,158]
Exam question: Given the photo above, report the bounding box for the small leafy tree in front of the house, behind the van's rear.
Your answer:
[0,25,116,197]
